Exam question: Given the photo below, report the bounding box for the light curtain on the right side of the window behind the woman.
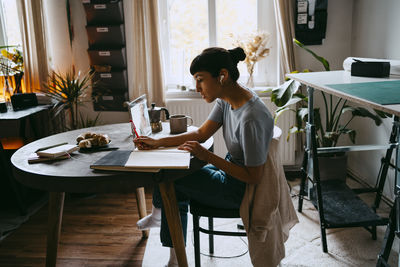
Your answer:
[274,0,296,82]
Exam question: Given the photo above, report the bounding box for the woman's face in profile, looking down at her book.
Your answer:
[193,71,221,103]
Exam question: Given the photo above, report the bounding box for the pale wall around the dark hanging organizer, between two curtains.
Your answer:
[43,0,129,124]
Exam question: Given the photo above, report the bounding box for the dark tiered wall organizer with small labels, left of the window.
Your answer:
[82,0,128,111]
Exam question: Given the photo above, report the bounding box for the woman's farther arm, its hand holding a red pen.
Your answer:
[133,120,221,149]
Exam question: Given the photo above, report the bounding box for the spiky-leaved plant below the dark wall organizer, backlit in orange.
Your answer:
[44,67,99,130]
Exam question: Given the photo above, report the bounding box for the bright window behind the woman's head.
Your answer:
[159,0,278,94]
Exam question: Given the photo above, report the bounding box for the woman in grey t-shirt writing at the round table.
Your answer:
[134,47,274,266]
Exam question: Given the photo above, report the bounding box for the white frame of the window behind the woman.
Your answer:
[159,0,279,98]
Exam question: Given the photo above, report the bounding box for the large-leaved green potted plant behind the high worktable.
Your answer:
[271,39,390,179]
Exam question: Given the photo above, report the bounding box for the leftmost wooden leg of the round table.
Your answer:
[46,192,65,267]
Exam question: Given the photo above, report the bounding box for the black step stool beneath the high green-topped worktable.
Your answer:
[298,124,388,252]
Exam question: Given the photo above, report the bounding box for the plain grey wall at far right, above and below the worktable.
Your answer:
[349,0,400,201]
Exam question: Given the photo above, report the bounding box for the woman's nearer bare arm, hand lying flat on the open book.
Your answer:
[179,141,264,184]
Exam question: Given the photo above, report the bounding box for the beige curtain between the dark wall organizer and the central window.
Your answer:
[129,0,165,105]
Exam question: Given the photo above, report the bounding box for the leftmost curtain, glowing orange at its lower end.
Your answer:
[17,0,48,92]
